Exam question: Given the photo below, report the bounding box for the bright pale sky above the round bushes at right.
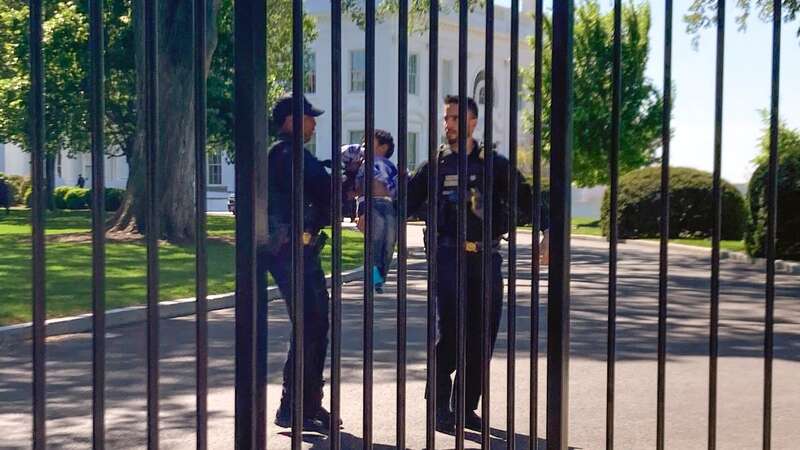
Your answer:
[499,0,800,183]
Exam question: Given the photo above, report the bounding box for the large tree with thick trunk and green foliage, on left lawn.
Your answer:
[0,0,315,241]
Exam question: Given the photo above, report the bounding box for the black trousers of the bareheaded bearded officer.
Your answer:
[436,246,503,411]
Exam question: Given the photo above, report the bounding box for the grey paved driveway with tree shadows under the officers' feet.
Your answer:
[0,228,800,449]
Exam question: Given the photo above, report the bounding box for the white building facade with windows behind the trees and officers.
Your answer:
[0,0,532,211]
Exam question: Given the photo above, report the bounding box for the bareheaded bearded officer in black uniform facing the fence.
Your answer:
[408,96,548,432]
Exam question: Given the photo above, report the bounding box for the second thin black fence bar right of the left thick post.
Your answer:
[330,0,342,444]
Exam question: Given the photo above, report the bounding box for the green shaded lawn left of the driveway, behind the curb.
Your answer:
[0,210,363,325]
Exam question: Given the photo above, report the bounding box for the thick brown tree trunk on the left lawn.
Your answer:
[111,0,220,242]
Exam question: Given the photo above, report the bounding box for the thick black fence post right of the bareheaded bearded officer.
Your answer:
[547,0,573,450]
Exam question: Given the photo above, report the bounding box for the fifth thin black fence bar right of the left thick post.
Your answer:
[425,0,439,444]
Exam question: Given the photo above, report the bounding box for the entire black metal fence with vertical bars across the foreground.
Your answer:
[21,0,781,449]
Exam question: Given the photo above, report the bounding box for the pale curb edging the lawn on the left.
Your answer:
[0,267,364,345]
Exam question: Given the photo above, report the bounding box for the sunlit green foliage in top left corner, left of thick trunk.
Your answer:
[0,0,136,154]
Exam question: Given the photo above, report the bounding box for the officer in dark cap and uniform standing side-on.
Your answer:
[259,95,338,432]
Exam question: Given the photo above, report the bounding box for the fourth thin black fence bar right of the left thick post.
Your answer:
[397,0,416,449]
